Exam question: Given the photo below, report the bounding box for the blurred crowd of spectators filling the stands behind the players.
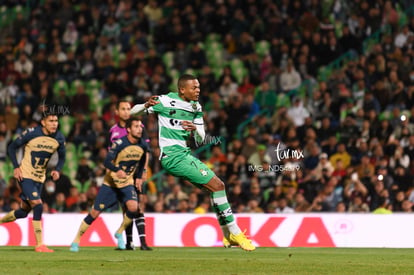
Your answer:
[0,0,414,216]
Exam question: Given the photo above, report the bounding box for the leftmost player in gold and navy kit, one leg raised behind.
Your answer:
[0,110,66,252]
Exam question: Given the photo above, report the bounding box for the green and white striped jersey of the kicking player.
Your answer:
[147,92,204,155]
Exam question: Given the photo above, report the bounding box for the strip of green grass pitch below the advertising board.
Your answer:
[0,246,414,275]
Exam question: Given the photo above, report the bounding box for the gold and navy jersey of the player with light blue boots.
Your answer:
[104,136,148,188]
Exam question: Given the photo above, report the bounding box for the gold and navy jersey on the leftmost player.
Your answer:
[9,126,66,183]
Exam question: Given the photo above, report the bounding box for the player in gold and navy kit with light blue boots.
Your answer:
[70,118,147,252]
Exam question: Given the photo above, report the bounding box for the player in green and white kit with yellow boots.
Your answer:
[131,74,256,251]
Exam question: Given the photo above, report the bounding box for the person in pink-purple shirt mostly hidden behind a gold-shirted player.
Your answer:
[109,100,152,250]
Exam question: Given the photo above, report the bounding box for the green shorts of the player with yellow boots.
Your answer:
[161,153,214,188]
